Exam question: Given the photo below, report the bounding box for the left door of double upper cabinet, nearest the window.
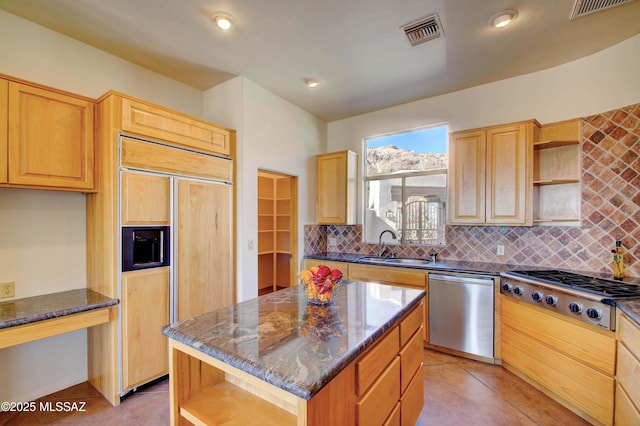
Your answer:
[448,130,486,225]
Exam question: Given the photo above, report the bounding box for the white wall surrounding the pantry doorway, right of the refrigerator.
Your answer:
[204,77,326,301]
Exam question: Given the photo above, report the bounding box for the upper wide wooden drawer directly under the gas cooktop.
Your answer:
[501,297,616,376]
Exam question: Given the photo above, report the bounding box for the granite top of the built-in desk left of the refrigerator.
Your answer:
[0,288,118,329]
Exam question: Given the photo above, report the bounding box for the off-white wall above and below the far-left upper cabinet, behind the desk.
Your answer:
[0,11,203,401]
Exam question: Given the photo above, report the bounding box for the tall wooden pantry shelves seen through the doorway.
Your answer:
[258,171,295,291]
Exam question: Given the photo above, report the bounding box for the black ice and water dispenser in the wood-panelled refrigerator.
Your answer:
[122,226,170,271]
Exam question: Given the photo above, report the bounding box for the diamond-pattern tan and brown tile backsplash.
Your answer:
[304,104,640,277]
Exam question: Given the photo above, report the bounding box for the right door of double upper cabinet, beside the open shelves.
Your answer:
[486,124,533,226]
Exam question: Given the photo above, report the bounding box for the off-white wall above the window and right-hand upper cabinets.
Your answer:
[327,35,640,220]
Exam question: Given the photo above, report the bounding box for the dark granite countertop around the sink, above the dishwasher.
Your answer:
[305,252,517,275]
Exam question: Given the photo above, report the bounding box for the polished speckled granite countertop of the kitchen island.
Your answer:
[162,280,425,400]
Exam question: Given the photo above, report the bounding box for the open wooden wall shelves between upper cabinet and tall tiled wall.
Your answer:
[533,119,581,226]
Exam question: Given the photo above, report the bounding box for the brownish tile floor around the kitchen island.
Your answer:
[0,350,589,426]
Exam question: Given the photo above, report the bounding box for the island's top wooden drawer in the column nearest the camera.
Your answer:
[356,327,400,396]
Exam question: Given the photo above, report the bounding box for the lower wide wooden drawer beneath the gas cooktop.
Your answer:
[501,324,615,424]
